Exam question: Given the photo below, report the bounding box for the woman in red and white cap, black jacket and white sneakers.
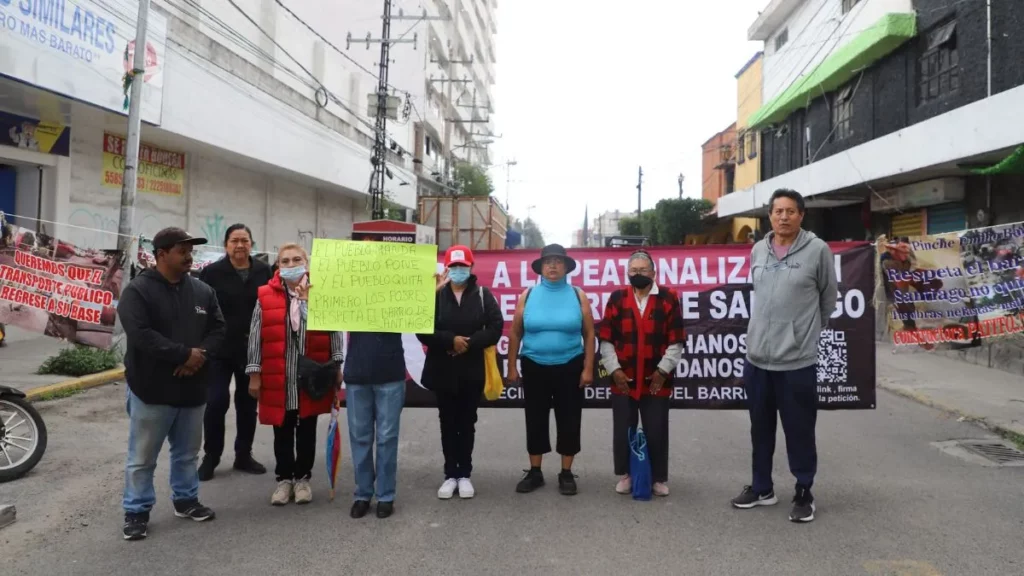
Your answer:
[418,241,504,500]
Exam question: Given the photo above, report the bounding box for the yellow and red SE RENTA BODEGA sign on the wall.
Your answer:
[102,132,185,196]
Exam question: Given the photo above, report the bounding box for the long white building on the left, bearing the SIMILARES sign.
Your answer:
[0,0,496,250]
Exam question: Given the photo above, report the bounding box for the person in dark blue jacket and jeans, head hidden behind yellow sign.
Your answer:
[344,332,406,519]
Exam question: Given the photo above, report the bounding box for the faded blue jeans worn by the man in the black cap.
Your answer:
[123,386,206,513]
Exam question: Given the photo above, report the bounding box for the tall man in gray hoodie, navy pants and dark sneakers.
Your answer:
[732,189,839,522]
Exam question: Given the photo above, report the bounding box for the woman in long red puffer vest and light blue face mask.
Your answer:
[246,244,344,506]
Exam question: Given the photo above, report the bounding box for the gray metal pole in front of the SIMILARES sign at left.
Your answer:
[115,0,150,341]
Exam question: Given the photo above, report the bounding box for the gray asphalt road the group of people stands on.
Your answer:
[0,385,1024,576]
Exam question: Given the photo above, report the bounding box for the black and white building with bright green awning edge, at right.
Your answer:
[718,0,1024,240]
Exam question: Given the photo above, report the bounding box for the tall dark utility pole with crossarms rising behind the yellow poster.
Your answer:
[346,0,417,220]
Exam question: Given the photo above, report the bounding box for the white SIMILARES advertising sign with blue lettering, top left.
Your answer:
[0,0,167,124]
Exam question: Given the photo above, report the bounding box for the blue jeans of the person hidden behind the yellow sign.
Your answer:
[345,380,406,502]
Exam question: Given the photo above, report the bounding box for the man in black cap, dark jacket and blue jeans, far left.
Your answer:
[118,228,224,540]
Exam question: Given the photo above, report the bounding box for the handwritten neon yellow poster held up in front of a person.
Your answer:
[308,238,437,334]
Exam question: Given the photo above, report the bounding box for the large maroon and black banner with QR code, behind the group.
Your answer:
[387,242,876,410]
